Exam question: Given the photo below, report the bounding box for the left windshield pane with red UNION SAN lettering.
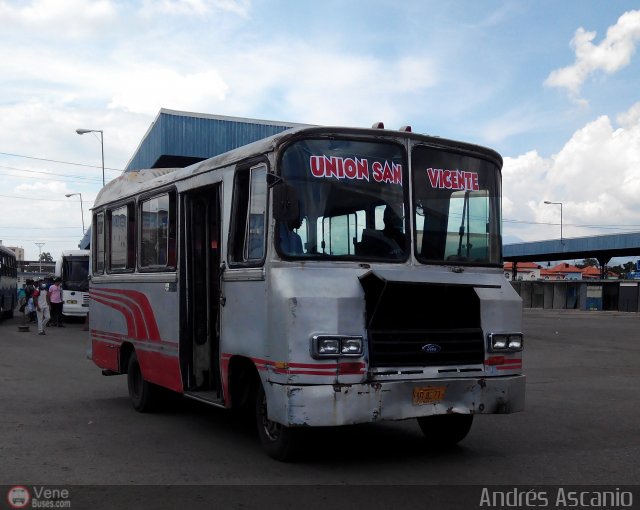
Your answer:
[274,139,409,261]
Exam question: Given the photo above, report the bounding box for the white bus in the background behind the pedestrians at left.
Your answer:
[55,250,90,317]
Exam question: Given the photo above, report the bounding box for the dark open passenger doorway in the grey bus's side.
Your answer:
[181,185,221,400]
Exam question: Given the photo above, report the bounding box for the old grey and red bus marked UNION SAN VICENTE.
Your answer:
[90,127,525,460]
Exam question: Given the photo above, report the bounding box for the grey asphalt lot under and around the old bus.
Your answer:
[0,310,640,508]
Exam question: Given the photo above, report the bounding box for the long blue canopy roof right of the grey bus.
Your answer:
[503,232,640,278]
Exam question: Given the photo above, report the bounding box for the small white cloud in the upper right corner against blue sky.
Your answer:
[544,11,640,101]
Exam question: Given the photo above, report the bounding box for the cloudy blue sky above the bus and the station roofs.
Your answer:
[0,0,640,259]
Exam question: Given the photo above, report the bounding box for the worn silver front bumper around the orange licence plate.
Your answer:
[265,375,525,427]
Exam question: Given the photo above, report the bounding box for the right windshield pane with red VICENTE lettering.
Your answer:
[412,146,502,265]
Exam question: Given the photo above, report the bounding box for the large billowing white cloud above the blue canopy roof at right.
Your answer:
[503,104,640,240]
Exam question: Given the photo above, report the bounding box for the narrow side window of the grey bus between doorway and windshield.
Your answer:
[229,165,267,264]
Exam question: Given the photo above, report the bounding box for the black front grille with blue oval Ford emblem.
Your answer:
[369,328,484,367]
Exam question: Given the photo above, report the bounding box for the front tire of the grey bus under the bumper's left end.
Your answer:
[256,381,303,462]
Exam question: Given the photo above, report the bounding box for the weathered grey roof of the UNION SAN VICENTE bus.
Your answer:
[93,126,502,208]
